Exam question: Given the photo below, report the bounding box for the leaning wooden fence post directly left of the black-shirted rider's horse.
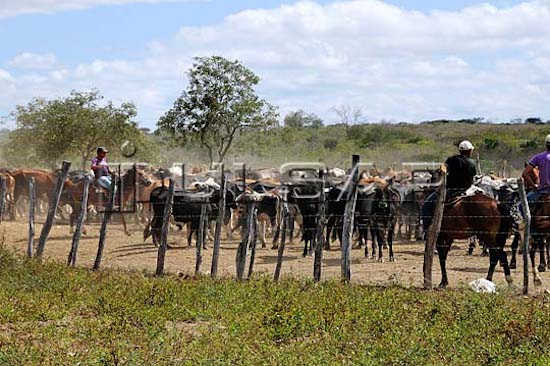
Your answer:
[423,172,447,290]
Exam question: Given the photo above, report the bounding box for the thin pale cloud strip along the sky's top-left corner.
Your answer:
[0,0,203,19]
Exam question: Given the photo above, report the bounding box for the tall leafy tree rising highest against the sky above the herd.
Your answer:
[157,56,278,164]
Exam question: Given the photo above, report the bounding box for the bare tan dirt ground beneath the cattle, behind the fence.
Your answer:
[0,219,550,291]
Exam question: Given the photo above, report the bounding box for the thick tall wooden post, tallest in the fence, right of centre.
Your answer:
[342,165,359,282]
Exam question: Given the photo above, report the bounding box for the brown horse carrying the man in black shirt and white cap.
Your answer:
[436,194,512,287]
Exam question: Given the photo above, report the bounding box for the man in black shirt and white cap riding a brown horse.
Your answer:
[422,140,476,233]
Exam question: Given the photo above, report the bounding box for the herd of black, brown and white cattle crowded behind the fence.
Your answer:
[1,164,549,285]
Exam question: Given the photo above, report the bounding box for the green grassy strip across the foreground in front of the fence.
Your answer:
[0,249,550,365]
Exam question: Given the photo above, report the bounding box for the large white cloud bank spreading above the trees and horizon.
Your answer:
[5,0,550,127]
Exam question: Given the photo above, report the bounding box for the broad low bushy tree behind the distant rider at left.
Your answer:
[6,90,144,169]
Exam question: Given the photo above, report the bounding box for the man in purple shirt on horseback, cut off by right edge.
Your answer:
[522,135,550,210]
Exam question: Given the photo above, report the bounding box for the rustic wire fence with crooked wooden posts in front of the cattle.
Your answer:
[0,161,544,292]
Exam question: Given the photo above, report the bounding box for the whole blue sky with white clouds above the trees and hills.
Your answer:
[0,0,550,127]
